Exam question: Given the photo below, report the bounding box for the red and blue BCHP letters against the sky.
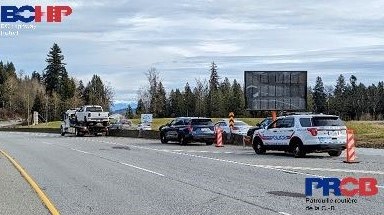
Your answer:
[1,5,72,23]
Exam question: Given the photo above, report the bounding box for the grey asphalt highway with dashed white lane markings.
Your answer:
[0,132,384,215]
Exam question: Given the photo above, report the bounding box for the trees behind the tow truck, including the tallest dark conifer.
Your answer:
[0,43,113,122]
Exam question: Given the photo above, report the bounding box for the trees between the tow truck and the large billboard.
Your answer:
[132,62,247,118]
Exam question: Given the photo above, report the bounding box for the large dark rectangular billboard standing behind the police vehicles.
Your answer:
[244,71,307,111]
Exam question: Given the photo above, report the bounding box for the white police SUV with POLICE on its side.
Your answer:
[252,114,347,157]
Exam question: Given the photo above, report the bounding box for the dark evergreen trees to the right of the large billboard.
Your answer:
[308,75,384,120]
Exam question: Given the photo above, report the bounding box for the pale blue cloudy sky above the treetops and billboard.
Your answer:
[0,0,384,106]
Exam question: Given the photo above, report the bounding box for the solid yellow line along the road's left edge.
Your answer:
[0,150,60,215]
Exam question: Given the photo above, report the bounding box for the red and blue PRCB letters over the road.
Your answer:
[305,177,379,196]
